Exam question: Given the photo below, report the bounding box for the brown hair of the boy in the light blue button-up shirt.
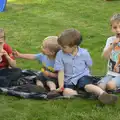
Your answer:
[58,28,82,47]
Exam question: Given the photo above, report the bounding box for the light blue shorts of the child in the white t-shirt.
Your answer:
[97,75,120,88]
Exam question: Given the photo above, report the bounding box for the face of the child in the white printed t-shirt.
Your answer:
[112,21,120,38]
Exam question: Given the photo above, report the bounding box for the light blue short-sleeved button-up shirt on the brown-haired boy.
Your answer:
[54,47,92,85]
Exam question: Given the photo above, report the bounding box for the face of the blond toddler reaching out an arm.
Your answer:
[41,41,55,57]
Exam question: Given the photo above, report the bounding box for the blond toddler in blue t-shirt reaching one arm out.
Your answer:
[14,36,60,91]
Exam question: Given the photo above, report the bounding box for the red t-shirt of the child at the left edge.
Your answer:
[0,43,14,69]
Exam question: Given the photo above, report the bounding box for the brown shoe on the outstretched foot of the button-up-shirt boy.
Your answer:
[98,92,118,104]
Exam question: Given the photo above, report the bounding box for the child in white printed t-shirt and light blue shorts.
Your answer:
[94,14,120,90]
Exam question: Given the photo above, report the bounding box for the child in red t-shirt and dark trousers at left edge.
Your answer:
[0,28,21,87]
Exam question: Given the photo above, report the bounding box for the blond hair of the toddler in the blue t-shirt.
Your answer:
[44,36,61,54]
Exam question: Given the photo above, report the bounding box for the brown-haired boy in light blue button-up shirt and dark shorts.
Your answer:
[54,29,117,104]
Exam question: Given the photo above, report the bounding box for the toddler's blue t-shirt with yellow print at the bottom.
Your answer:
[35,53,55,72]
